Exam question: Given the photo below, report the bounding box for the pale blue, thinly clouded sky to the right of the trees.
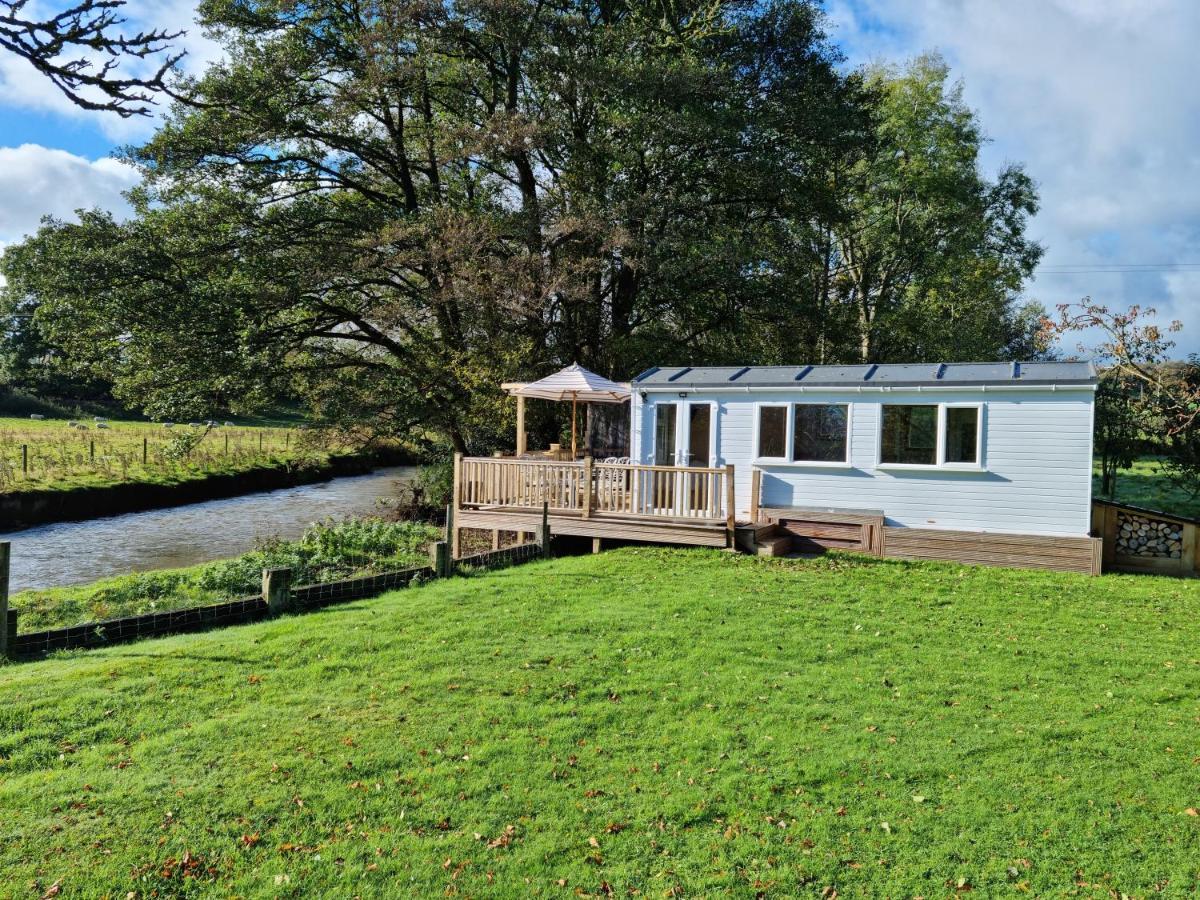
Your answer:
[828,0,1200,352]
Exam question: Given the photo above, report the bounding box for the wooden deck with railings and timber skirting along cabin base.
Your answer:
[451,456,1099,575]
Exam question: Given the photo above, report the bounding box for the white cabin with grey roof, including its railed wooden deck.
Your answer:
[456,362,1102,574]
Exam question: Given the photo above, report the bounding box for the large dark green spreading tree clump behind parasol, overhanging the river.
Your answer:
[5,0,859,449]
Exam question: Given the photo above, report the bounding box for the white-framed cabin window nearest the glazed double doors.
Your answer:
[757,403,850,466]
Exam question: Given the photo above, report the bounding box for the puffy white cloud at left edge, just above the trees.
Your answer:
[0,144,139,245]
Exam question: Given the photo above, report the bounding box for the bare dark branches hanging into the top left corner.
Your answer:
[0,0,184,116]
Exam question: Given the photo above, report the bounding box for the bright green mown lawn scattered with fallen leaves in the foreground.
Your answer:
[0,548,1200,898]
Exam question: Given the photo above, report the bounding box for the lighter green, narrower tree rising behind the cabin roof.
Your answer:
[822,55,1042,362]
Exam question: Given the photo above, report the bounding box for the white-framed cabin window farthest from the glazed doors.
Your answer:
[880,403,980,467]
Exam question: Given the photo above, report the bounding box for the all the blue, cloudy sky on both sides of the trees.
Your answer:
[0,0,1200,353]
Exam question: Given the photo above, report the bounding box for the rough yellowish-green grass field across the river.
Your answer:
[0,418,328,492]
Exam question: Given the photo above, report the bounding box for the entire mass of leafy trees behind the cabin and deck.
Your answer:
[2,0,1039,451]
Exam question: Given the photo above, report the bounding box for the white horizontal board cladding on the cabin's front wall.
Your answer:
[630,384,1094,535]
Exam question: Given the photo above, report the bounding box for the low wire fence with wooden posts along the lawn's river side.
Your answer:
[0,529,551,659]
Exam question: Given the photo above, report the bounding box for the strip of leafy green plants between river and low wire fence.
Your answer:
[11,518,442,631]
